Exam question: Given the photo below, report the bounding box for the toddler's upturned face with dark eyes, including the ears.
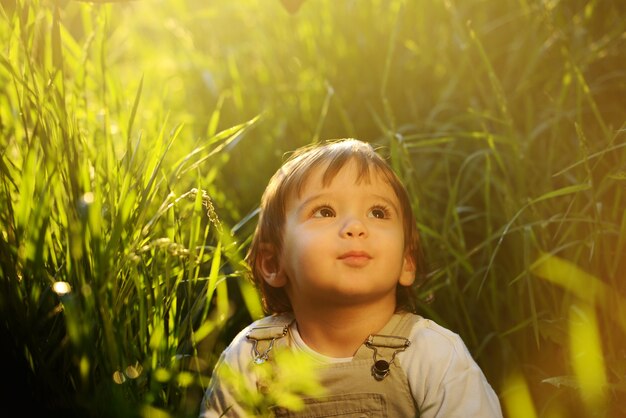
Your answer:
[278,162,415,308]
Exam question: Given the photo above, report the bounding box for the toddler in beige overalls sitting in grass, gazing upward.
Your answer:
[200,139,502,418]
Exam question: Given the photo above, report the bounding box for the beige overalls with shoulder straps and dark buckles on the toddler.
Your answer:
[246,313,419,418]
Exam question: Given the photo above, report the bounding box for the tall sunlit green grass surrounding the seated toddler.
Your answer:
[0,0,626,418]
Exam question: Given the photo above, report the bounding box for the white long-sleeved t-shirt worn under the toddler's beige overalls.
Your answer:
[200,317,502,418]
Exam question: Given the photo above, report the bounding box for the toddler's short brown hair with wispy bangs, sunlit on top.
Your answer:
[246,138,423,313]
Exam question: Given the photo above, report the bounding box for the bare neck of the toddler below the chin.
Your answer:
[294,301,395,357]
